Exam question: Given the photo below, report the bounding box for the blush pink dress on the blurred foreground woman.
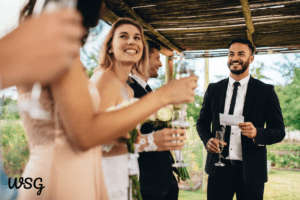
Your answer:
[18,82,108,200]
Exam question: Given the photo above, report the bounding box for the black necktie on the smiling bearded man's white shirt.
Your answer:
[222,82,241,158]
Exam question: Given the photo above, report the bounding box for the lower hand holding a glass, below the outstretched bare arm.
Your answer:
[153,128,187,151]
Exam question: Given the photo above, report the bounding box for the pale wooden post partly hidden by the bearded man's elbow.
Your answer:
[202,50,209,192]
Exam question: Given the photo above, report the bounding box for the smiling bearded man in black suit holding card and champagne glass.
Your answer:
[197,38,285,200]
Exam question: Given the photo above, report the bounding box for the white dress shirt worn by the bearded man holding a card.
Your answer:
[224,75,250,161]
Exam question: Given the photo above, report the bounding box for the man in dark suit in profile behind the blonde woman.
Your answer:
[127,41,179,200]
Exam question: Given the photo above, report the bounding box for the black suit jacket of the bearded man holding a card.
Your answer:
[197,77,285,184]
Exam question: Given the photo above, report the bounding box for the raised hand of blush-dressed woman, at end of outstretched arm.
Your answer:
[157,76,198,105]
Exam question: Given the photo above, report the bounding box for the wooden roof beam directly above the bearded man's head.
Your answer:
[240,0,256,52]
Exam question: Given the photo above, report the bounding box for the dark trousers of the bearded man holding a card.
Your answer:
[207,159,265,200]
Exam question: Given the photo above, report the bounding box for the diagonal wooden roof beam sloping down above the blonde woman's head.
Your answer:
[108,0,182,52]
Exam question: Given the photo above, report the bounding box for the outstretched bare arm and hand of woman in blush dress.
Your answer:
[51,58,198,150]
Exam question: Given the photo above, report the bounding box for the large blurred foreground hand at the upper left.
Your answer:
[0,10,84,88]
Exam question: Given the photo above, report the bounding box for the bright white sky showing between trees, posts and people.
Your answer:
[0,0,294,99]
